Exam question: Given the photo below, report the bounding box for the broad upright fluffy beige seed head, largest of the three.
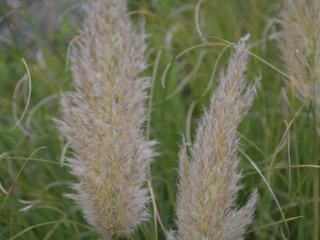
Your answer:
[59,0,154,239]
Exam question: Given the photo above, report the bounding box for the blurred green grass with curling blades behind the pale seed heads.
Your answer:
[0,0,320,240]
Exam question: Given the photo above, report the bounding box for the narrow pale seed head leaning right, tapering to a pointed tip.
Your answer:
[174,38,257,240]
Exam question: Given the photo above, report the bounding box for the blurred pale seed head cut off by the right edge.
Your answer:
[279,0,320,105]
